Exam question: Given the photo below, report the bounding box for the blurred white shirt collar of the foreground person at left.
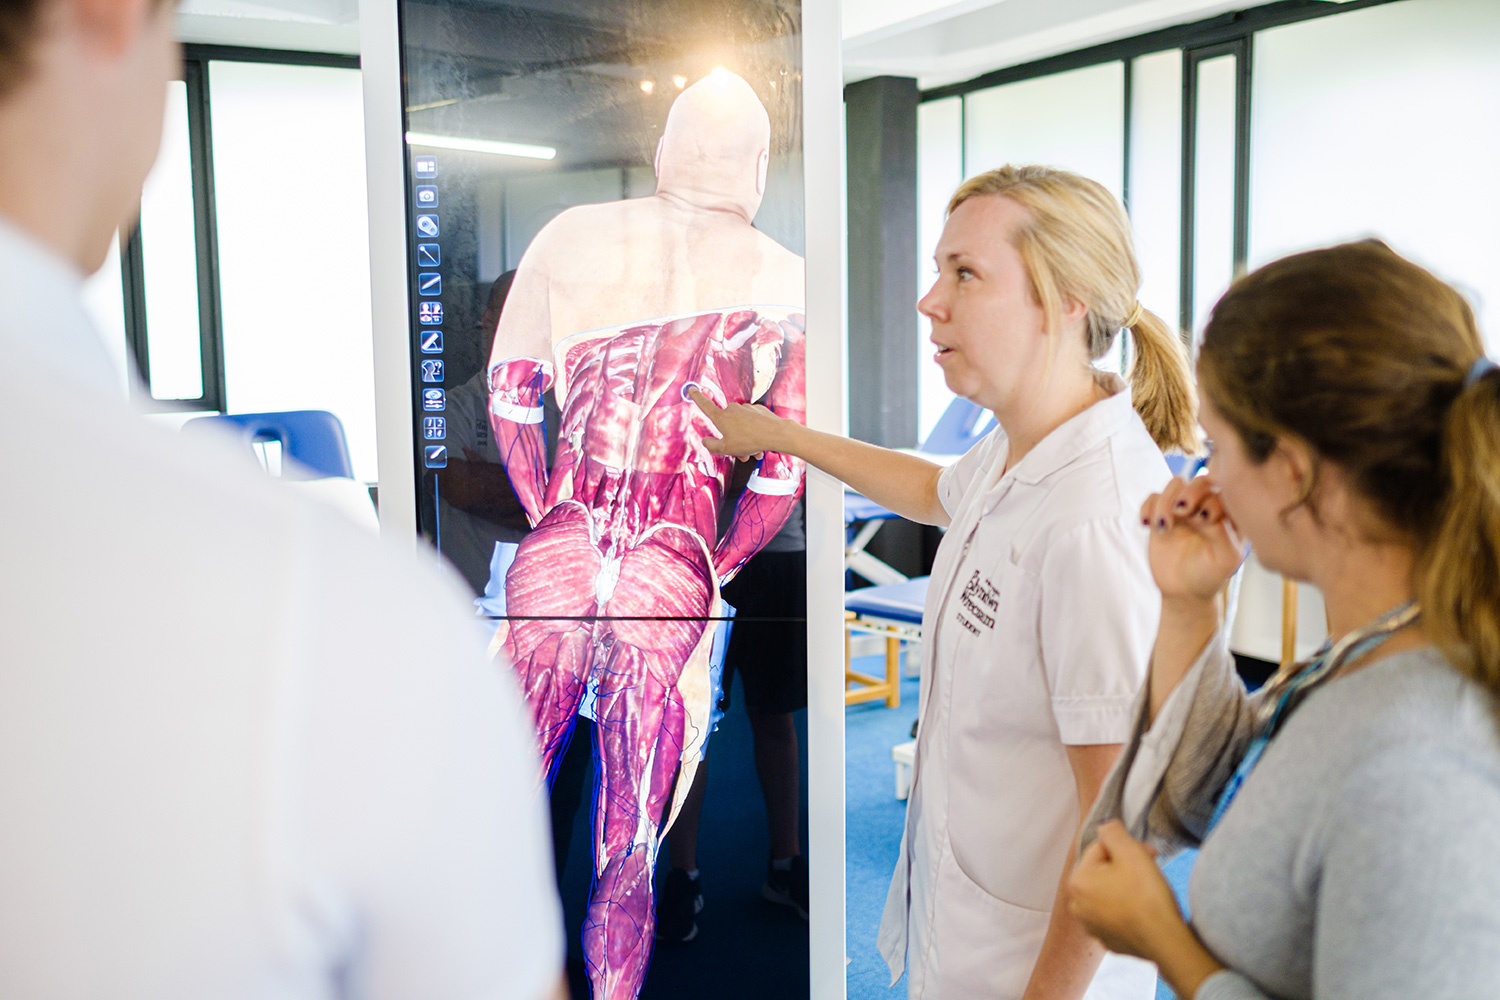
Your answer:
[0,217,125,400]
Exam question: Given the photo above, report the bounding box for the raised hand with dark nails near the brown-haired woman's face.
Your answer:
[1140,475,1250,600]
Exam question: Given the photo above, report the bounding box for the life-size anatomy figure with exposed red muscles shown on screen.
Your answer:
[489,69,806,1000]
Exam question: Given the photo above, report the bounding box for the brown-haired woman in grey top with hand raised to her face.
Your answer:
[1071,241,1500,1000]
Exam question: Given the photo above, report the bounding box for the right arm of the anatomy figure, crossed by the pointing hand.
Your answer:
[714,324,807,585]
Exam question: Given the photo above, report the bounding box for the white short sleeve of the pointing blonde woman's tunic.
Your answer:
[1038,517,1161,745]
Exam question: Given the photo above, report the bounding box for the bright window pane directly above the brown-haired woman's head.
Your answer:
[1250,0,1500,344]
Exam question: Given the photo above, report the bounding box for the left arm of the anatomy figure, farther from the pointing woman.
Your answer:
[489,248,552,528]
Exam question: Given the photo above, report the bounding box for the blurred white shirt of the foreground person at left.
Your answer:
[0,222,563,1000]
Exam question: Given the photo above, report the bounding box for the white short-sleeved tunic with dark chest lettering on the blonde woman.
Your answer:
[879,390,1172,1000]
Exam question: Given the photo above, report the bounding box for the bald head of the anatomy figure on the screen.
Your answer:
[656,69,771,222]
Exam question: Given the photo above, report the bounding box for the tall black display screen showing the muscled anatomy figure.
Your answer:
[401,0,816,1000]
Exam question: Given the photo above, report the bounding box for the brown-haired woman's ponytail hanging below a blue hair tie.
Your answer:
[1416,372,1500,697]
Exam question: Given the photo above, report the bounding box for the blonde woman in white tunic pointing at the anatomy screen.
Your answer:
[695,166,1197,1000]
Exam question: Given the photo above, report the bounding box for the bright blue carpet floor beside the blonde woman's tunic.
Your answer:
[845,657,1197,1000]
